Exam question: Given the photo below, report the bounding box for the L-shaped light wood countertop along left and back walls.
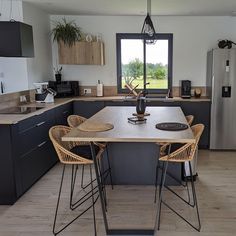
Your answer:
[0,96,210,124]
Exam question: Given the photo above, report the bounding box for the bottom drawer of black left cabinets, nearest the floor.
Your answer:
[19,140,58,194]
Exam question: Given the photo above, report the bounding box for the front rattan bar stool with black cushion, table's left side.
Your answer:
[49,125,104,235]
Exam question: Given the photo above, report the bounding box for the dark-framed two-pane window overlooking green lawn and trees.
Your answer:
[116,34,173,93]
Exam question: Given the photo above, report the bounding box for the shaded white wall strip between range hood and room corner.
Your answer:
[23,2,53,89]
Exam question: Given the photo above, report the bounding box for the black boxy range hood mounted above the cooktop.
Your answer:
[0,21,34,57]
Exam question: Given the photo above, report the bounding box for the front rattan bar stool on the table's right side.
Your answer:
[155,124,204,231]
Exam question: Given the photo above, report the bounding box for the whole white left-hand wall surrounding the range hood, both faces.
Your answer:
[0,0,53,93]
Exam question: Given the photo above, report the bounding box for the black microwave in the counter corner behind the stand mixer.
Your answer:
[48,81,79,98]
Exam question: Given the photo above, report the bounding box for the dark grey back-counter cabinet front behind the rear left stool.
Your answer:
[73,101,105,118]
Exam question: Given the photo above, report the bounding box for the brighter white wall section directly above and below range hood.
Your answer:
[0,0,28,92]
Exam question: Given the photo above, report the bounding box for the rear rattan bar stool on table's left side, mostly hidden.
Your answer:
[67,115,113,205]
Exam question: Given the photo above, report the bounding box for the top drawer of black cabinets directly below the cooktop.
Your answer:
[17,109,54,133]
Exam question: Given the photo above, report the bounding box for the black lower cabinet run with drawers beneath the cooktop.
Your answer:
[0,109,58,204]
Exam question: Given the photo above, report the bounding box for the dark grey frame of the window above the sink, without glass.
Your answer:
[116,33,173,94]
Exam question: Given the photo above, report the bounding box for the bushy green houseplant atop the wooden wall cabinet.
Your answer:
[52,18,82,47]
